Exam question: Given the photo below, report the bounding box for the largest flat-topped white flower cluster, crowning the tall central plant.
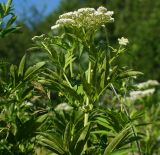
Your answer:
[51,6,114,30]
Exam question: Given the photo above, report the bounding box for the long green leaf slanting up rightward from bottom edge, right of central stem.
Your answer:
[103,127,130,155]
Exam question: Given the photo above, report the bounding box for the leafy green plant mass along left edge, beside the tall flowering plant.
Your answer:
[0,55,45,155]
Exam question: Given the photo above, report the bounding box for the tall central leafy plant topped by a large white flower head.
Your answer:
[32,7,144,155]
